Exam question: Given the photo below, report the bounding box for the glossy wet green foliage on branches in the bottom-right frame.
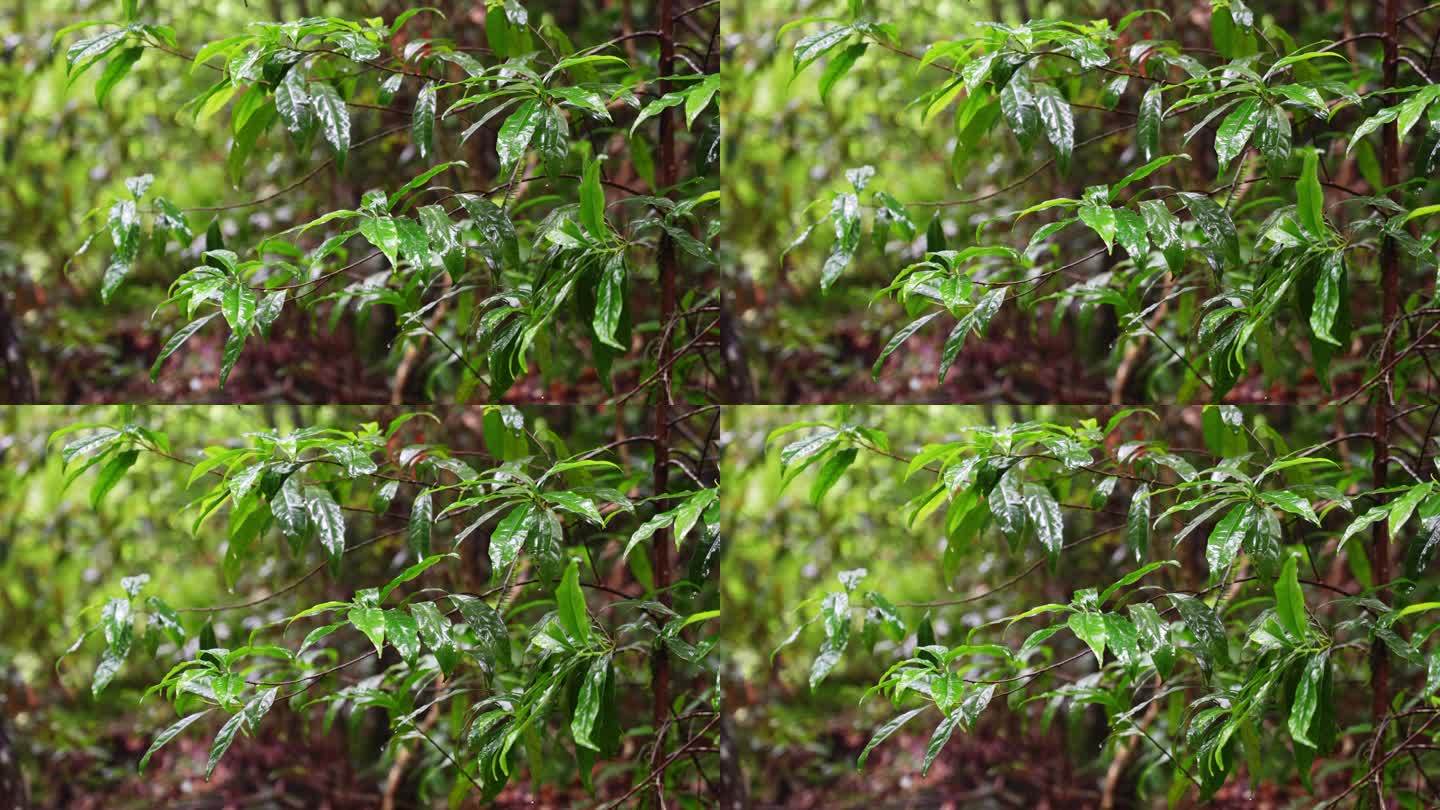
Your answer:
[748,406,1440,804]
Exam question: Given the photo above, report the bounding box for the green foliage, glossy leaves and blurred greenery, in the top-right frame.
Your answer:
[736,3,1440,402]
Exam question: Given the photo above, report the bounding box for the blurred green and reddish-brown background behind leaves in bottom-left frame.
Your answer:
[0,405,680,809]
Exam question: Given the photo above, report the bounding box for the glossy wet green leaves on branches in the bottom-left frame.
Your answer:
[23,406,720,800]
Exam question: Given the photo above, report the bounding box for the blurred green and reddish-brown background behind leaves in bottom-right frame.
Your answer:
[721,405,1370,809]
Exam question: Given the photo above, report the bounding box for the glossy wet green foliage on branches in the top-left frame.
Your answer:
[32,3,720,401]
